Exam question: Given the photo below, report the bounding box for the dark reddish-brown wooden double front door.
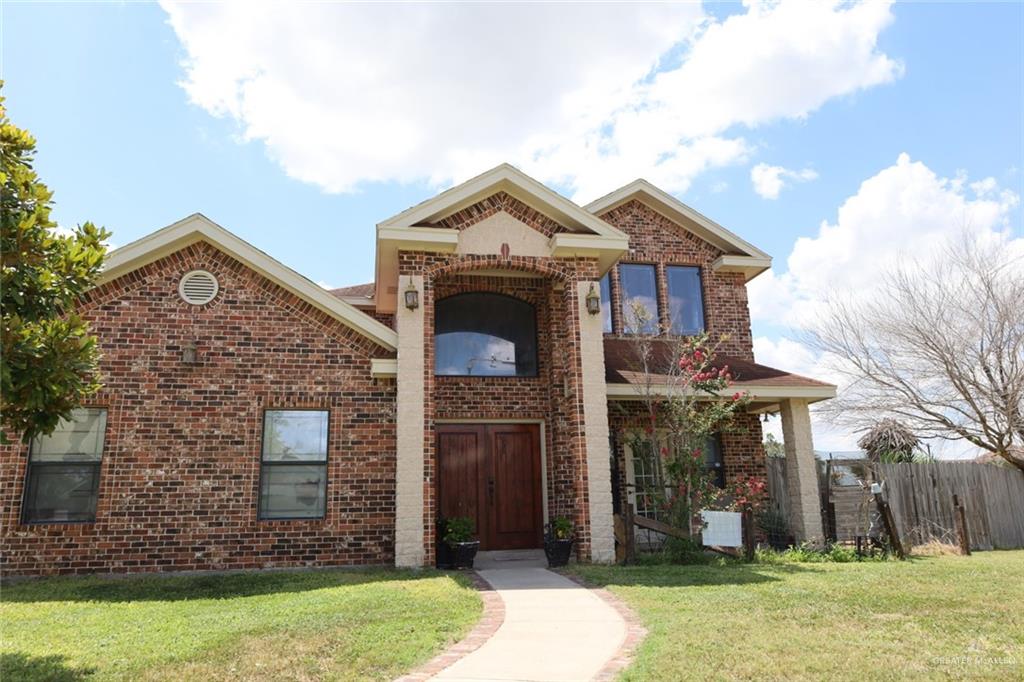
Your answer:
[437,424,544,550]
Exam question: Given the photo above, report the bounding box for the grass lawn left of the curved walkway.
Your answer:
[0,570,482,682]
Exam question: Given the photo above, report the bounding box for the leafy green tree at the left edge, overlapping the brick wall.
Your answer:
[0,89,110,441]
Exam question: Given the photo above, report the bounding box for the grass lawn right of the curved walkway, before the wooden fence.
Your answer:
[572,551,1024,681]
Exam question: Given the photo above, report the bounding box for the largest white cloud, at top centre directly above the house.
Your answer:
[162,0,902,199]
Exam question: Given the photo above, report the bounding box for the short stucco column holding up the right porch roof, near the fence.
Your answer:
[781,399,824,545]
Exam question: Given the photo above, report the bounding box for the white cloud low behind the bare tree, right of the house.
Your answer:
[749,154,1024,457]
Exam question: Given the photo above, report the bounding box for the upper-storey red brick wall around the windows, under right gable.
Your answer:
[601,200,754,360]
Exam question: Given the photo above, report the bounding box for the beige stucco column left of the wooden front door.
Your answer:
[394,275,426,566]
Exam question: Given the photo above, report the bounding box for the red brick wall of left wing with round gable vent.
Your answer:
[0,244,395,574]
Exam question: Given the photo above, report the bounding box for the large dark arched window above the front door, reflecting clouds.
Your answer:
[434,294,537,377]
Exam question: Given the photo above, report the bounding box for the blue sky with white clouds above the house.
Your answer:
[0,1,1024,446]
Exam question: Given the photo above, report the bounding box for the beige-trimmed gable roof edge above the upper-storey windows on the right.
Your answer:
[584,179,771,280]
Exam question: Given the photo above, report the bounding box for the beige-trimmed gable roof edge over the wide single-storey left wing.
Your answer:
[99,213,398,350]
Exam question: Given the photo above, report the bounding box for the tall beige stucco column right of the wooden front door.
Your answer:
[577,282,615,563]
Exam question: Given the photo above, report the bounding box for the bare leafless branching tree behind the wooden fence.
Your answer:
[804,235,1024,470]
